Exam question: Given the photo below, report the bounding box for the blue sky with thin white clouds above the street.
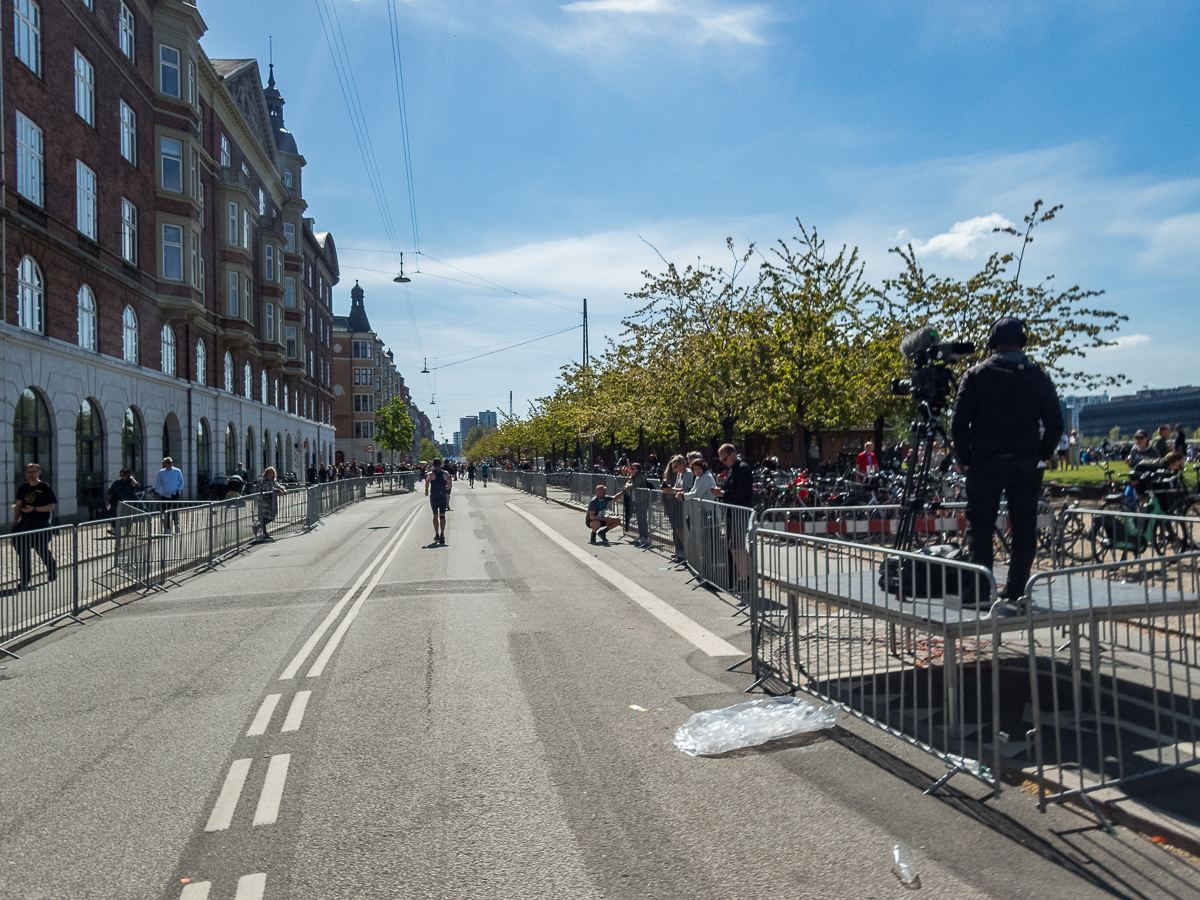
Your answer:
[199,0,1200,444]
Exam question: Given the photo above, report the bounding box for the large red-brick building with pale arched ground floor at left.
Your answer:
[0,0,338,521]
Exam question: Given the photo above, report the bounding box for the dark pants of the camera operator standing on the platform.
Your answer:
[967,456,1043,600]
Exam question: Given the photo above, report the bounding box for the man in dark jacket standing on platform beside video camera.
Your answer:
[950,316,1063,607]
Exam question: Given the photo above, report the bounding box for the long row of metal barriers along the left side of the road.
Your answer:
[0,473,415,655]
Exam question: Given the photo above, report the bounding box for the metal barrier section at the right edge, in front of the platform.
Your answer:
[1020,556,1200,809]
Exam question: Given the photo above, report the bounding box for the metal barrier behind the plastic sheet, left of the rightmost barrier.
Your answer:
[750,510,1003,792]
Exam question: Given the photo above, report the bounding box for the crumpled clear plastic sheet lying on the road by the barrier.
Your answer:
[674,697,838,756]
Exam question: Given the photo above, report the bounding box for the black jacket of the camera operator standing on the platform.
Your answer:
[950,356,1062,467]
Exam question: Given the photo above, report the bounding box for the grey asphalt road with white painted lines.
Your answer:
[0,485,1200,900]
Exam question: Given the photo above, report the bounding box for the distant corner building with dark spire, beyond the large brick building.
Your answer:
[332,282,433,463]
